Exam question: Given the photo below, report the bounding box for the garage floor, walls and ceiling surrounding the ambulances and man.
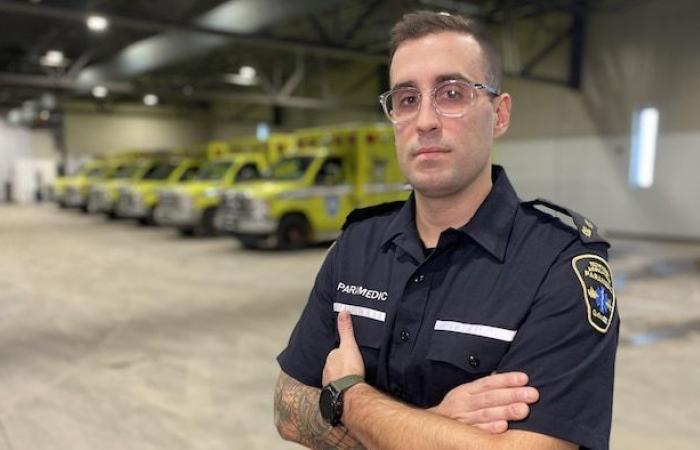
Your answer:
[0,0,700,450]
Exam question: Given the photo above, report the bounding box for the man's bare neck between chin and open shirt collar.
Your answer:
[415,167,493,248]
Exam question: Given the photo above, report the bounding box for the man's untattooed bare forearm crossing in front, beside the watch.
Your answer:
[343,383,576,450]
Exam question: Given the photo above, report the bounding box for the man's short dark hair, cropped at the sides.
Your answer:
[389,11,503,90]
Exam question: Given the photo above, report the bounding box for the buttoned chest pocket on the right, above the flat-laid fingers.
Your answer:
[426,330,510,406]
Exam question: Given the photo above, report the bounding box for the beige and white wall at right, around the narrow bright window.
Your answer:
[496,0,700,238]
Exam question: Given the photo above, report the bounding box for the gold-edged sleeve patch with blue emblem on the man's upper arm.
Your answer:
[571,254,615,334]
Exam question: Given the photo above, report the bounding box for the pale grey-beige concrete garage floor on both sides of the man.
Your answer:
[0,205,700,450]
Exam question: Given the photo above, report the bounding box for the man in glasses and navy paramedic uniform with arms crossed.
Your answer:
[275,12,619,450]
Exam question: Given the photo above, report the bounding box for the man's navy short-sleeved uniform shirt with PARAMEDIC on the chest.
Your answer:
[278,166,619,450]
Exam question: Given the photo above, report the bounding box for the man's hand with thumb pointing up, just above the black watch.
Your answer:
[322,311,365,386]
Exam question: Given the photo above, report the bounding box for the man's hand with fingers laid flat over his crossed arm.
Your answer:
[430,372,539,433]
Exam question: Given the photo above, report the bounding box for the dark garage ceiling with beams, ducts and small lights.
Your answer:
[0,0,635,125]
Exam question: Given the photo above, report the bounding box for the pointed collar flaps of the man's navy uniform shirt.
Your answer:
[382,165,520,262]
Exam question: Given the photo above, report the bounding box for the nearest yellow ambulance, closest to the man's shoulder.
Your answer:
[220,124,409,249]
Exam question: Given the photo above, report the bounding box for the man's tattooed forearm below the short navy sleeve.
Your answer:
[275,373,364,450]
